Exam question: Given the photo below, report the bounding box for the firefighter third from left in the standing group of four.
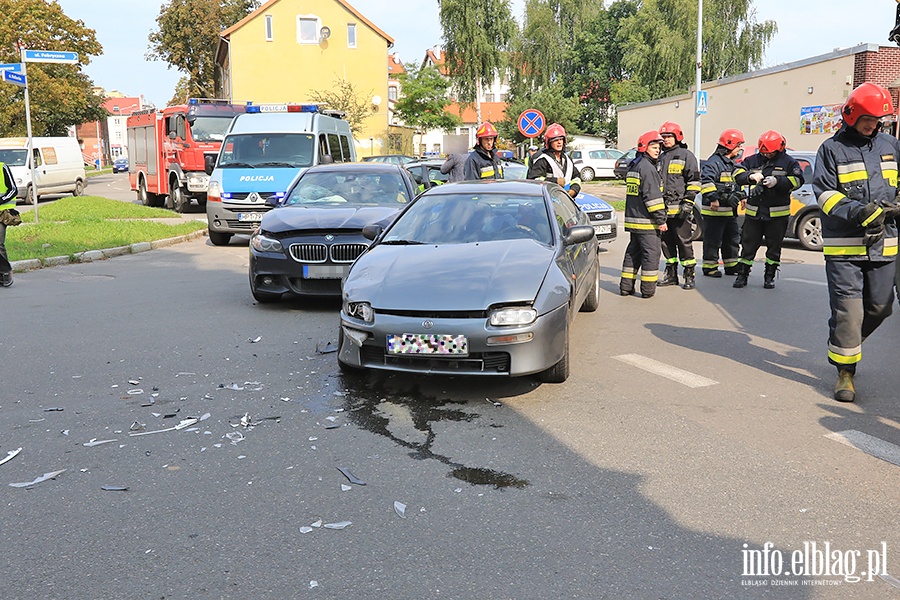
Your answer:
[700,129,746,277]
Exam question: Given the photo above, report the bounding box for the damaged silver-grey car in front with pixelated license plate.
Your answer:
[338,181,600,383]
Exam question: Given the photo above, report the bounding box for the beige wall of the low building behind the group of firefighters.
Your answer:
[618,51,854,158]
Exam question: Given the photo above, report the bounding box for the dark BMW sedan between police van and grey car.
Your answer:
[250,163,415,302]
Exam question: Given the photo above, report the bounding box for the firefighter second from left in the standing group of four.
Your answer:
[659,121,700,290]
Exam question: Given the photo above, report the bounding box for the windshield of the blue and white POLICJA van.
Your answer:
[218,133,315,169]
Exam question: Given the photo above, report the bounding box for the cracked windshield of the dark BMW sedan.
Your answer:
[284,170,411,208]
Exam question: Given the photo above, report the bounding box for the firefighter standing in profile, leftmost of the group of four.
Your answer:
[619,131,667,298]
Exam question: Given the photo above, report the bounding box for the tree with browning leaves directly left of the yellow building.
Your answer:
[146,0,259,100]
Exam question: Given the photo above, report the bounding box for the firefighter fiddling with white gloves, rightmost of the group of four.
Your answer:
[734,130,803,290]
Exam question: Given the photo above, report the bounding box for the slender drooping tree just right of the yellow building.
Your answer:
[438,0,518,122]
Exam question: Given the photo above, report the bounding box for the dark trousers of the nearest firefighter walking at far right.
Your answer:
[825,260,895,373]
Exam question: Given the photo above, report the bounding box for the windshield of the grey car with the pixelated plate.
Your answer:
[383,193,553,245]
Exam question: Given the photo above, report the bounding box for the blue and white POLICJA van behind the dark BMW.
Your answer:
[206,104,356,246]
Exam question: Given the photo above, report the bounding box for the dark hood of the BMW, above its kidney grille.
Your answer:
[260,206,401,233]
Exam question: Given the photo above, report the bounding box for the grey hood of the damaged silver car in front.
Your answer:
[344,240,555,311]
